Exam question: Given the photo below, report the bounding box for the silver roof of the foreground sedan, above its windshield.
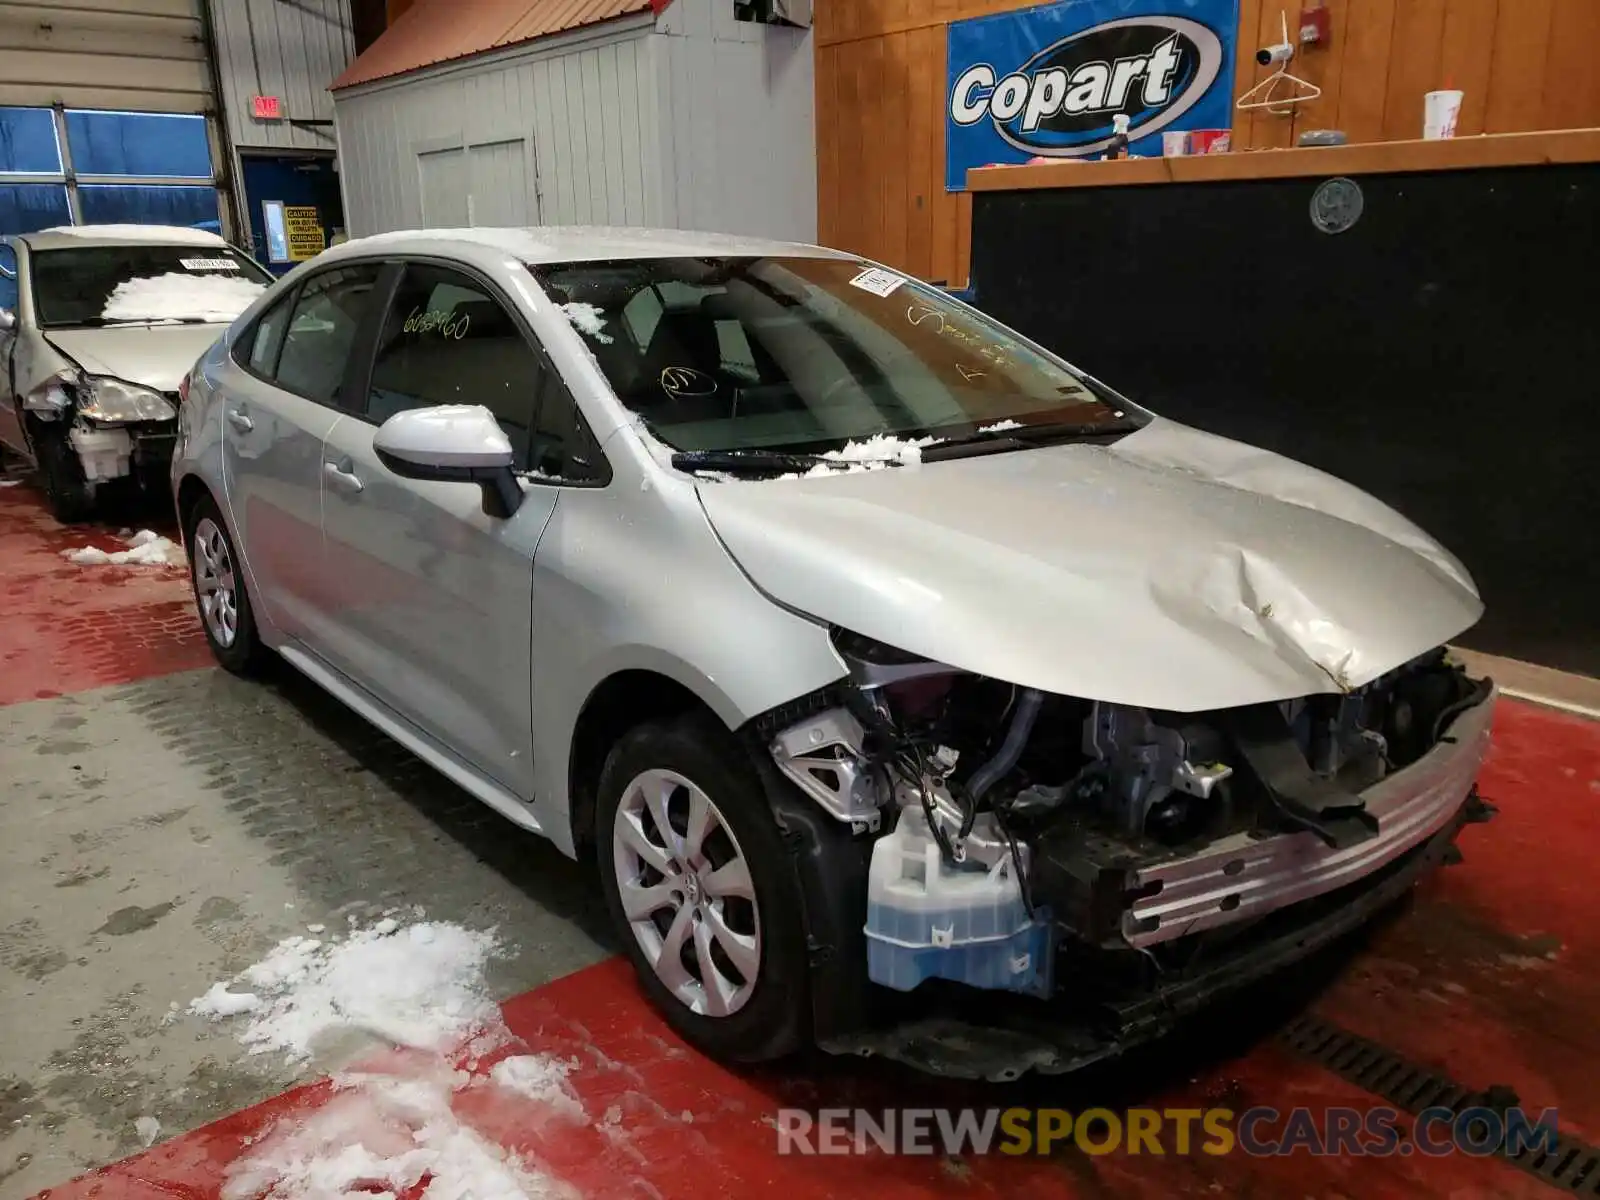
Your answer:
[318,226,848,262]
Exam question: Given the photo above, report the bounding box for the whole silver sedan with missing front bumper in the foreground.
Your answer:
[173,229,1494,1077]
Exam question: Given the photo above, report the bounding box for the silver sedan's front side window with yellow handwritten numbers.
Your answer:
[366,264,546,462]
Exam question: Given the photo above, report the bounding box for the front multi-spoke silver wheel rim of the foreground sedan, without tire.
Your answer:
[611,770,762,1016]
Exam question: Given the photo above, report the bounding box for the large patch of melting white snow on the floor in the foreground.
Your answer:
[189,918,586,1200]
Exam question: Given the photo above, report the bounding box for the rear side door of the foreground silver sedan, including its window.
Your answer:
[222,262,384,640]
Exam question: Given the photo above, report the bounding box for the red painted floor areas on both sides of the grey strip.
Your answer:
[9,473,1600,1200]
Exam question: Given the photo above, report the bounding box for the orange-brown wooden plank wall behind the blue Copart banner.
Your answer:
[814,0,1600,283]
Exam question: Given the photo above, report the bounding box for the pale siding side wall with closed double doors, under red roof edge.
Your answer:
[334,18,659,237]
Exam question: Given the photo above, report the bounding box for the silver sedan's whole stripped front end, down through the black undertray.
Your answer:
[762,629,1496,1078]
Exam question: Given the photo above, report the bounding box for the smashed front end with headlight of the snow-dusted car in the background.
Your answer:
[22,366,179,496]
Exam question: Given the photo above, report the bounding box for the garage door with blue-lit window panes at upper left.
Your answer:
[0,0,221,234]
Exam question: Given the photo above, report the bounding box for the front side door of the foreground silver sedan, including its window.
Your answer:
[312,264,560,797]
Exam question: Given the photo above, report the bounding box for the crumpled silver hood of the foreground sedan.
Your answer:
[699,419,1483,712]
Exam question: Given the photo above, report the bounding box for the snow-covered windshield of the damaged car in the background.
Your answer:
[27,245,272,330]
